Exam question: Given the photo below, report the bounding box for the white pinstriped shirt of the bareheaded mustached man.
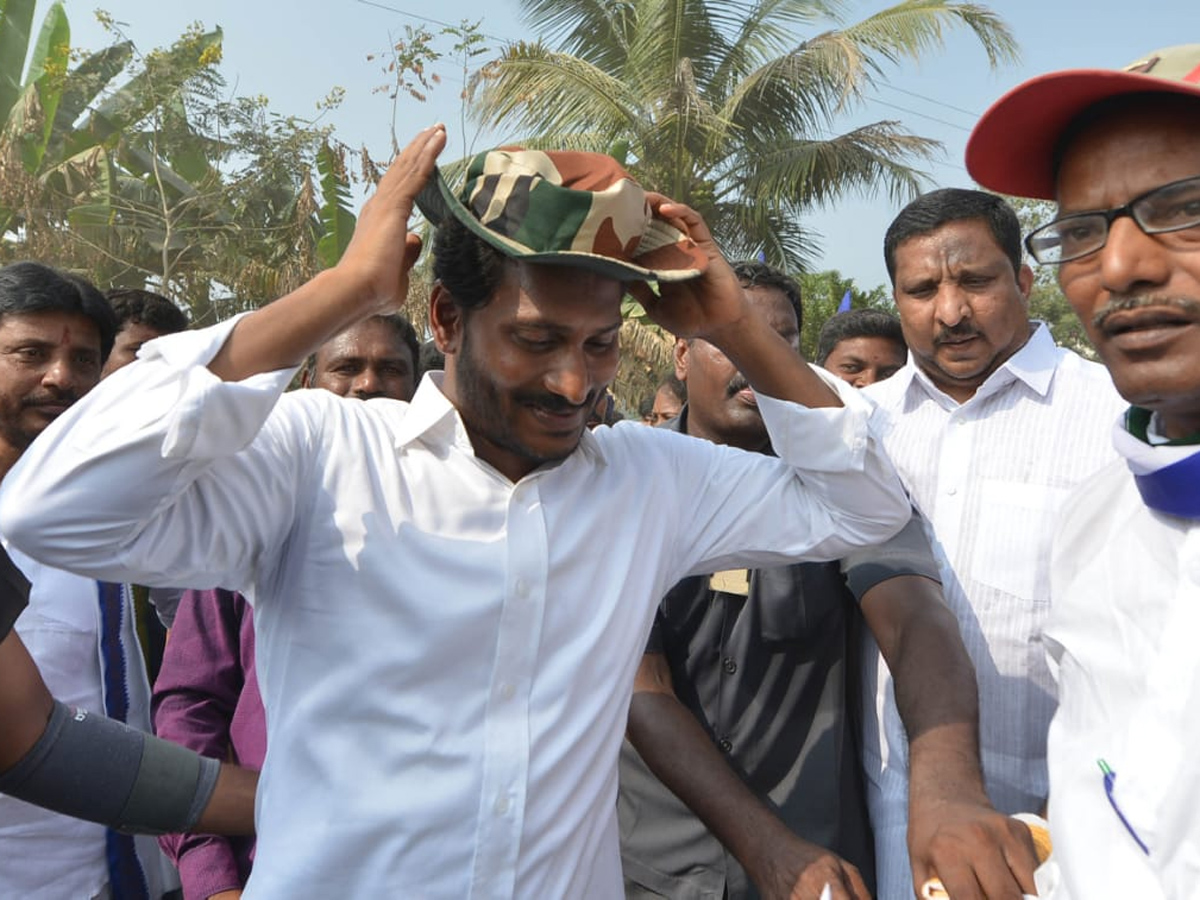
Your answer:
[863,324,1123,900]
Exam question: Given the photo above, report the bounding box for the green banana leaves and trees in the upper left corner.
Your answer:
[0,9,346,323]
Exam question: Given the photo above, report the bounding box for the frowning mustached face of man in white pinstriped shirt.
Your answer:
[894,218,1033,403]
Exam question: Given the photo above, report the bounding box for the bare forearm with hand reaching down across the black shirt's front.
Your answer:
[628,653,870,900]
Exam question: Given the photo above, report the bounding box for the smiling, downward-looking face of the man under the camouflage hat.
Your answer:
[431,263,624,481]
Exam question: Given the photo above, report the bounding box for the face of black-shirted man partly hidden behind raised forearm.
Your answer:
[676,287,800,450]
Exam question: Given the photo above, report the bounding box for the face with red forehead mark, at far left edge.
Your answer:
[0,312,101,464]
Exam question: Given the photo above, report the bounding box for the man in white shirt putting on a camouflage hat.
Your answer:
[0,126,908,899]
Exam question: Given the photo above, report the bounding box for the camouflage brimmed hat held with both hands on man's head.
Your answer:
[416,148,708,282]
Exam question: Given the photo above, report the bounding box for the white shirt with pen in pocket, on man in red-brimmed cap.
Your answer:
[1038,426,1200,900]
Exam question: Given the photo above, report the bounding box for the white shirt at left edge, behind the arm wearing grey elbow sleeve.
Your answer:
[0,548,178,900]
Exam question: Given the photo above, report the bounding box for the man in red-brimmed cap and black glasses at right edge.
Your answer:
[967,44,1200,900]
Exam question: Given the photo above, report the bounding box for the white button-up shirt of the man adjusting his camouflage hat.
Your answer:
[0,323,908,900]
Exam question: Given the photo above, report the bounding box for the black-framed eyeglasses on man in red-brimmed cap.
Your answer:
[1025,175,1200,265]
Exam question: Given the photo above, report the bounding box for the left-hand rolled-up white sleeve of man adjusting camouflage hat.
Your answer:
[0,320,311,588]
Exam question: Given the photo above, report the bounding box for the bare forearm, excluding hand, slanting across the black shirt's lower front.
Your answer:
[628,691,787,877]
